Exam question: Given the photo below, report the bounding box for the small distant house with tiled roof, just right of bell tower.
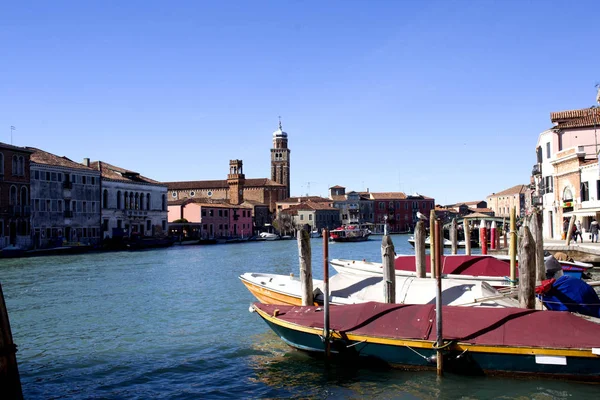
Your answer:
[281,200,342,232]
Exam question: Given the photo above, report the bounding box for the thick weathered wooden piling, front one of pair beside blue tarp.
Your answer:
[519,226,536,310]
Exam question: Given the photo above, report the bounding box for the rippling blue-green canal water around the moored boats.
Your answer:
[0,235,600,399]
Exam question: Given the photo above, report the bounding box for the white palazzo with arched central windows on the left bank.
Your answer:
[91,159,168,239]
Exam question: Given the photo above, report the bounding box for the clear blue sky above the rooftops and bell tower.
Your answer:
[0,0,600,204]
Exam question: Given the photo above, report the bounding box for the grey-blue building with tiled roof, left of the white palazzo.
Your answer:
[27,147,101,248]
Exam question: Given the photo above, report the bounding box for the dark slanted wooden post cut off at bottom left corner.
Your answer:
[0,284,23,400]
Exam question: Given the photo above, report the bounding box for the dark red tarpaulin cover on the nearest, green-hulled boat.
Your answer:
[254,302,600,349]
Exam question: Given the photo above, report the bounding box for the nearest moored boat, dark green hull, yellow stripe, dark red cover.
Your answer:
[250,302,600,382]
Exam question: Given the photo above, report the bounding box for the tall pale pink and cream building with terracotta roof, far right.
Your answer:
[531,108,600,239]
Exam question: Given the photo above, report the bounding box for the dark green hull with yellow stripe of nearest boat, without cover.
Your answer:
[253,306,600,382]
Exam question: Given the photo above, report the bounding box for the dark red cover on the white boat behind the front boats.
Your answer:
[394,255,519,276]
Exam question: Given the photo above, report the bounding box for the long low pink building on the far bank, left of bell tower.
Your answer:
[169,199,252,238]
